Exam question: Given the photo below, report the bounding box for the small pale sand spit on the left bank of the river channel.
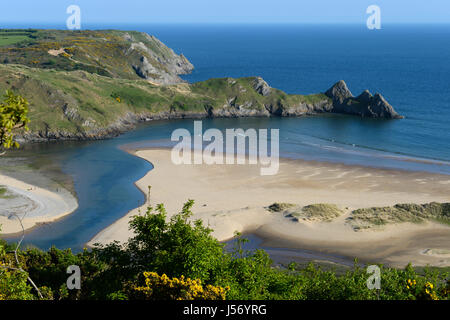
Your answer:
[0,175,78,235]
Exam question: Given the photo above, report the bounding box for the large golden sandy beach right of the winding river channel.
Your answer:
[88,149,450,266]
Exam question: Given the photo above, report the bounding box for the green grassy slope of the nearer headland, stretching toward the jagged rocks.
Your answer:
[0,64,328,133]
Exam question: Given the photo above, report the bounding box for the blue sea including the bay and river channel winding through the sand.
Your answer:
[0,25,450,250]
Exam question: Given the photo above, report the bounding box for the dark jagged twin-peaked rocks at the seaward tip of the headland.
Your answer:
[325,80,403,119]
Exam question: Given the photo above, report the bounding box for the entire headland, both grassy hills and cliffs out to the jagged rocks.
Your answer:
[0,30,402,142]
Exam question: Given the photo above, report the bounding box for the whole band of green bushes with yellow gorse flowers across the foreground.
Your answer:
[0,201,450,300]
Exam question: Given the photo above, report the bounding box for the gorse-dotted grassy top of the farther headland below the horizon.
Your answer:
[0,30,186,79]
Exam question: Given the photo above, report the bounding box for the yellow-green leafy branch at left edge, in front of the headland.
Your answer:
[0,90,29,150]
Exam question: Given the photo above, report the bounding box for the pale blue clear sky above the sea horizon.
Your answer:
[0,0,450,28]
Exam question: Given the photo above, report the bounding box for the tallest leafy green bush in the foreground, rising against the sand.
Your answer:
[127,200,224,281]
